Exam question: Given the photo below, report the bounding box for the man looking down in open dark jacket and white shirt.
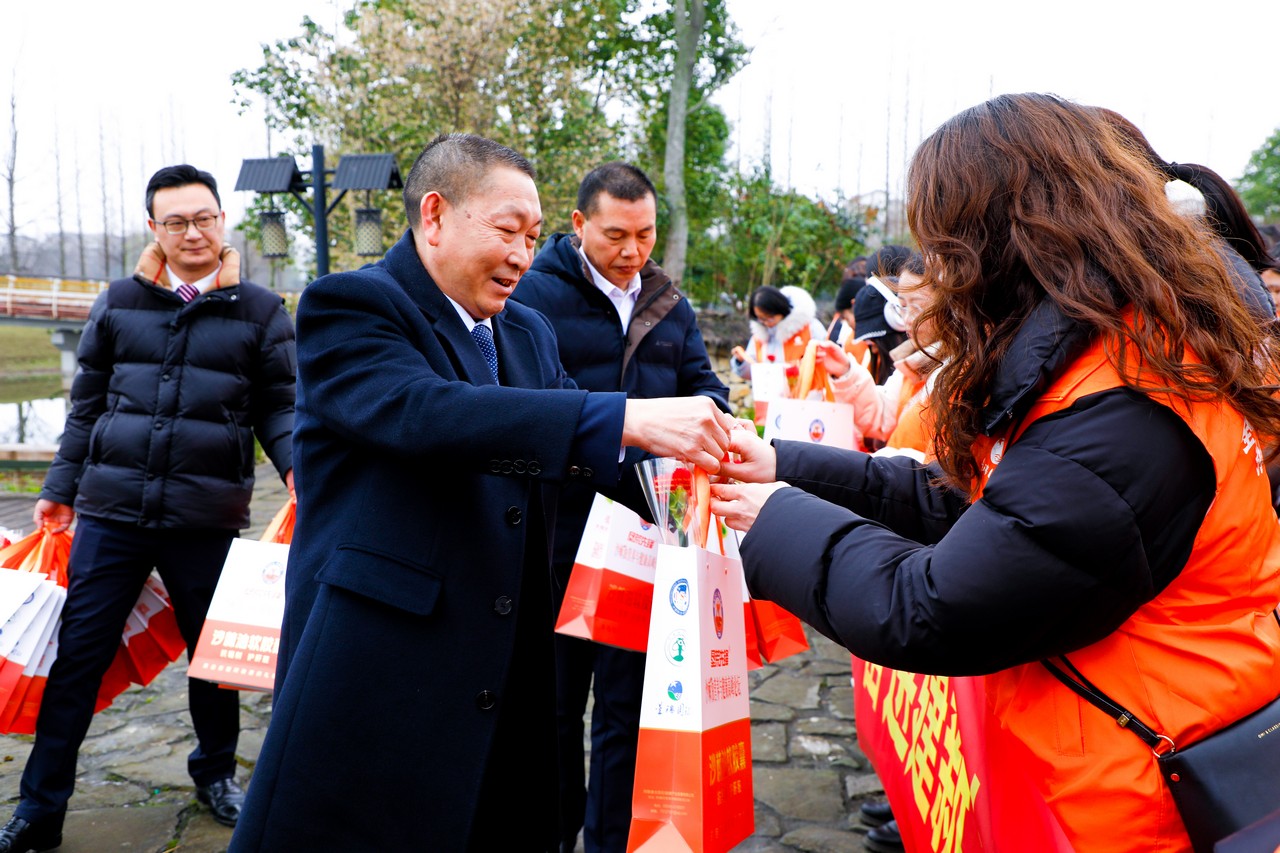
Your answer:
[512,163,730,853]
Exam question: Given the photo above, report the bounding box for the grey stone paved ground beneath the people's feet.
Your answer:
[0,469,882,853]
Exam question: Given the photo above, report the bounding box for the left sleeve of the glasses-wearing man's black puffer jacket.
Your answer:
[40,292,113,506]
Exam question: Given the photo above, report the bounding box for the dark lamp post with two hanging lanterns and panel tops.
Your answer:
[236,145,404,278]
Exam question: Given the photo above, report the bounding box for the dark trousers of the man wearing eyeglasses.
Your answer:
[15,516,239,821]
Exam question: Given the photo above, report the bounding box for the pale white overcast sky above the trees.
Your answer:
[0,0,1280,244]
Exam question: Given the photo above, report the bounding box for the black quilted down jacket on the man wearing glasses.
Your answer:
[41,278,297,530]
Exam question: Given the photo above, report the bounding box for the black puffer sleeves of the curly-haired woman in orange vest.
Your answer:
[742,389,1215,675]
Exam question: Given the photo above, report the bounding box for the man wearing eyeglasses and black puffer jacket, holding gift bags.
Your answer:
[0,165,296,853]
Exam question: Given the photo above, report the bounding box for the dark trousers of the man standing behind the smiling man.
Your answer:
[556,634,645,853]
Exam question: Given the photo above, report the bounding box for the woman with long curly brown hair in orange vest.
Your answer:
[713,95,1280,852]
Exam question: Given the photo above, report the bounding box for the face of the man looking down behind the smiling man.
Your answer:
[573,192,658,289]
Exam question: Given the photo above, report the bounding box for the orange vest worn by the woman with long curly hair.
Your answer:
[974,333,1280,853]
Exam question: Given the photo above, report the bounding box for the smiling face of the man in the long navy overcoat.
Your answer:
[415,167,543,320]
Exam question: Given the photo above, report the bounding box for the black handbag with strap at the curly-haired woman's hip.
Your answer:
[1041,657,1280,853]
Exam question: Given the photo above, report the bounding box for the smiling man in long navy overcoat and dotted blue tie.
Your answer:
[232,134,732,852]
